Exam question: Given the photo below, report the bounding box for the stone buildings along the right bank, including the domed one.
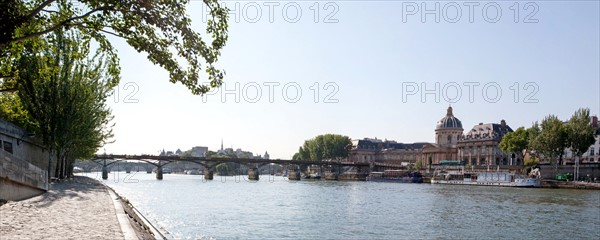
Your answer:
[349,106,600,166]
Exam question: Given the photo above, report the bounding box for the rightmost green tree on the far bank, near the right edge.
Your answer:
[567,108,595,157]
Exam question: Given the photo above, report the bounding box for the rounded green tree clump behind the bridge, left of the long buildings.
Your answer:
[293,134,352,161]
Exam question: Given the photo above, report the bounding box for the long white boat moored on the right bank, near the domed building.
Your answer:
[431,170,540,187]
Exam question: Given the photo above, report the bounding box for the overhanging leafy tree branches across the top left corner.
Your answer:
[0,0,228,94]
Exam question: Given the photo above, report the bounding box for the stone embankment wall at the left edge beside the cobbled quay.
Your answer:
[0,119,50,201]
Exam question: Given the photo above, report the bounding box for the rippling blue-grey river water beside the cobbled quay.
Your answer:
[84,172,600,239]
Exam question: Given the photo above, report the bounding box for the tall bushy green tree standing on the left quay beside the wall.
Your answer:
[14,31,118,178]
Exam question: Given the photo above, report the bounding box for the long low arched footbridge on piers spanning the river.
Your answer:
[85,154,402,180]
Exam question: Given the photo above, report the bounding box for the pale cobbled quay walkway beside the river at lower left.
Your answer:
[0,177,124,240]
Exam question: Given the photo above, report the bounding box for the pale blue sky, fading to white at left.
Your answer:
[99,1,600,159]
